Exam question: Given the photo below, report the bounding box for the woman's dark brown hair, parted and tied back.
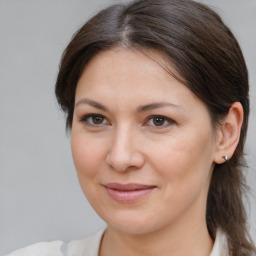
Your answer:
[56,0,255,256]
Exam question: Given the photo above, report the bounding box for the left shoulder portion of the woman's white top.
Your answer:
[6,230,104,256]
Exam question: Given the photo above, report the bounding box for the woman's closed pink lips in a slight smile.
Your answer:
[104,183,156,203]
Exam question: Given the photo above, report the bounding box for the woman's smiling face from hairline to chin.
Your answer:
[71,49,217,234]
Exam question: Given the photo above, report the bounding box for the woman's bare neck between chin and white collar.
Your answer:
[99,216,213,256]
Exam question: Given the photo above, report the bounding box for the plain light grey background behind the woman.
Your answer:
[0,0,256,255]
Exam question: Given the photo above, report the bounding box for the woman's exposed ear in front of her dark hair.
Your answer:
[213,102,244,164]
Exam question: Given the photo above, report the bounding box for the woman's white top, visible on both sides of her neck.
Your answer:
[6,229,228,256]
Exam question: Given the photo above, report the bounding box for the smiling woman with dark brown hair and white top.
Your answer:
[7,0,255,256]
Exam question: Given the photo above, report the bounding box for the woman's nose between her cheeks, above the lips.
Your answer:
[107,124,144,171]
